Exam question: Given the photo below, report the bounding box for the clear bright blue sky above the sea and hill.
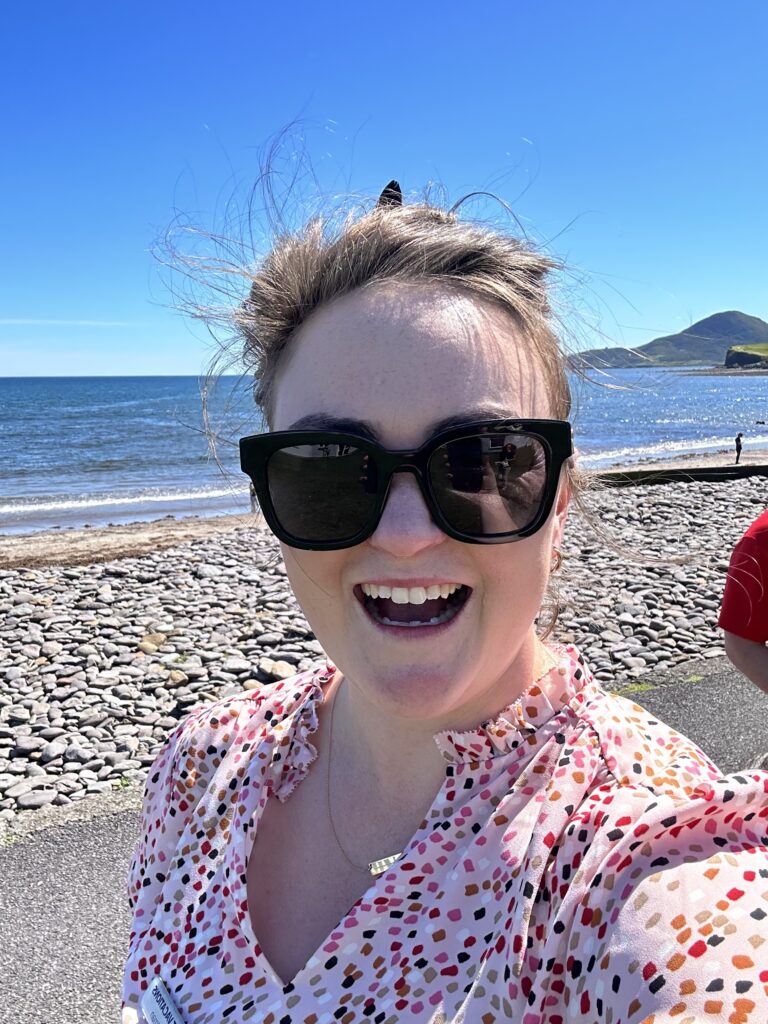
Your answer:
[0,0,768,376]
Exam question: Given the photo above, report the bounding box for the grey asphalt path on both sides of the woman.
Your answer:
[0,657,768,1024]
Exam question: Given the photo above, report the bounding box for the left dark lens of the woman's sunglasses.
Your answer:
[266,444,378,542]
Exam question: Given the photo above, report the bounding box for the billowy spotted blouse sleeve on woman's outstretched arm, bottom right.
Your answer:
[566,772,768,1024]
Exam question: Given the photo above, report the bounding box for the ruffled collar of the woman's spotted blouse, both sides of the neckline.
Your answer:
[269,644,598,800]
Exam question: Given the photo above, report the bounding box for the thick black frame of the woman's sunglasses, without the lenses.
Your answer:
[240,420,573,551]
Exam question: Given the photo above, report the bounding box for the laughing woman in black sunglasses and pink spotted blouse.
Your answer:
[123,182,768,1024]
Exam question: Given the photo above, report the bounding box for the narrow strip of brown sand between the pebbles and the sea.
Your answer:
[0,449,768,569]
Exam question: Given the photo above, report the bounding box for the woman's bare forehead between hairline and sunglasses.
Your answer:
[272,284,551,445]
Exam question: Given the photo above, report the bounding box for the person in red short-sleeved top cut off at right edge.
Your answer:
[718,509,768,693]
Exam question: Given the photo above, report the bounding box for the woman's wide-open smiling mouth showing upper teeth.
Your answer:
[354,584,472,629]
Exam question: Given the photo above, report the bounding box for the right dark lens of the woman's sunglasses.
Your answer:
[429,433,547,537]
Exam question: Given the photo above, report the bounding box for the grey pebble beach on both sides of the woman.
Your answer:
[0,476,768,820]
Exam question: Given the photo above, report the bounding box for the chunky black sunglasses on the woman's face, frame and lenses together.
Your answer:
[240,420,573,551]
